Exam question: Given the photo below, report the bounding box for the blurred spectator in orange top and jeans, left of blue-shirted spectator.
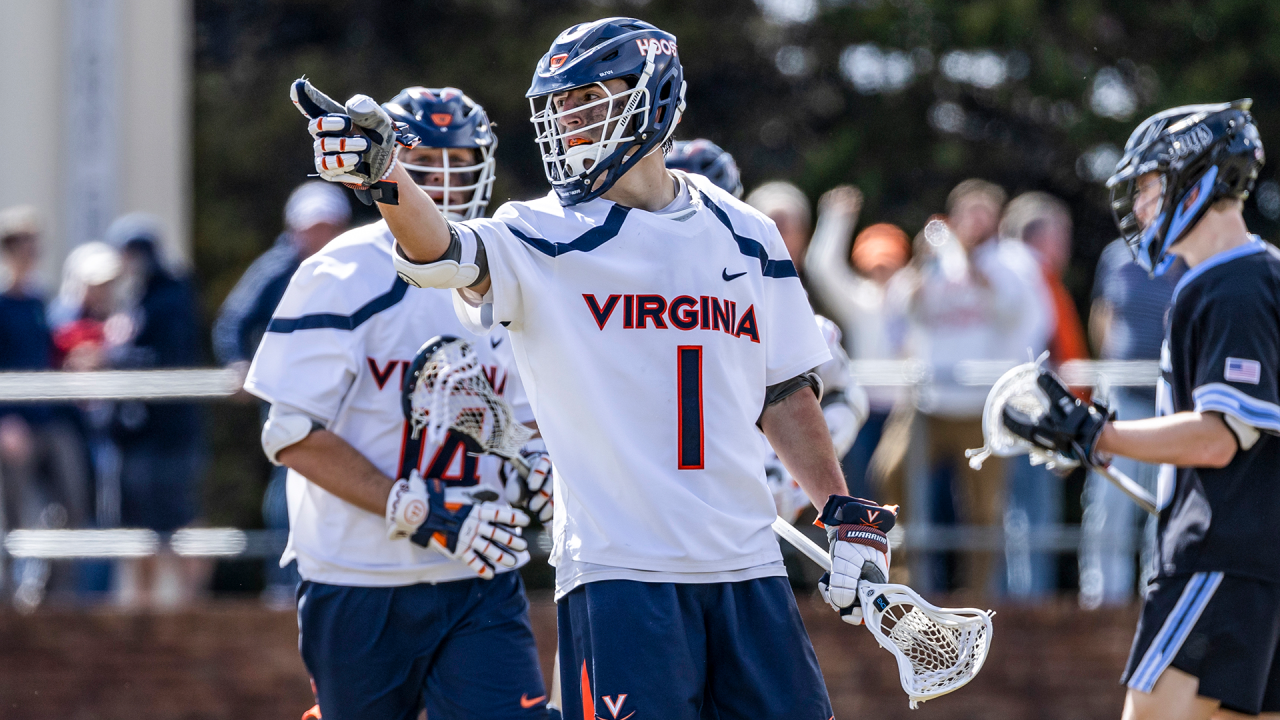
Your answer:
[1000,192,1089,597]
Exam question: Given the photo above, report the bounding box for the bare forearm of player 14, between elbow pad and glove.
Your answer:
[276,430,393,515]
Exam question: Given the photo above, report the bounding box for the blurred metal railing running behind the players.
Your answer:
[0,360,1160,589]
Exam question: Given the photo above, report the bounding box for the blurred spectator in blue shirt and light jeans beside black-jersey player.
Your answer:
[1080,240,1187,609]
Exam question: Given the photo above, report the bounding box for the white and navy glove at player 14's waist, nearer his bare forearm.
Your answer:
[387,470,529,580]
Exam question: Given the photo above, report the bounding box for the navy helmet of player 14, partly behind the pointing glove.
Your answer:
[383,87,498,220]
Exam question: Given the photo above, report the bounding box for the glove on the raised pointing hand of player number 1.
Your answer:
[289,78,420,205]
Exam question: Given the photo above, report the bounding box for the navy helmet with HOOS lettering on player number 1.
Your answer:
[525,18,685,206]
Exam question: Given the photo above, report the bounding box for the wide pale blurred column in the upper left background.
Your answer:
[0,0,193,283]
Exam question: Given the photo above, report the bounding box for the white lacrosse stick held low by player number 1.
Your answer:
[773,518,995,710]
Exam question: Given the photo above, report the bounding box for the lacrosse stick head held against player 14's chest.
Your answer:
[401,336,532,457]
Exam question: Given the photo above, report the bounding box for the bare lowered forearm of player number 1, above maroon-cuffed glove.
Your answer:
[760,388,849,511]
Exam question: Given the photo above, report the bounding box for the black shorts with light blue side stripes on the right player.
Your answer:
[1124,573,1280,715]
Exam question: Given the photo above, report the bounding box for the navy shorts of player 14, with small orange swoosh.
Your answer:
[298,573,547,720]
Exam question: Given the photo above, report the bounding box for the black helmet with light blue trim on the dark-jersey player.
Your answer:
[1107,99,1266,275]
